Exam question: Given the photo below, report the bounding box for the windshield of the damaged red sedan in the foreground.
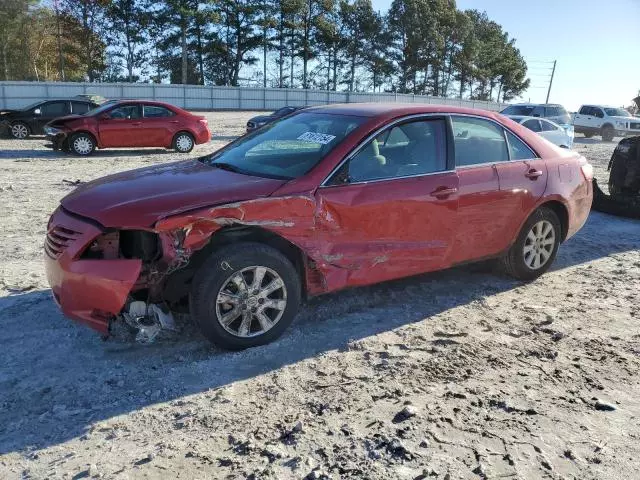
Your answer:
[203,112,366,179]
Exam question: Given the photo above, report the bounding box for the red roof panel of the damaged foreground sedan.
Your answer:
[307,103,496,118]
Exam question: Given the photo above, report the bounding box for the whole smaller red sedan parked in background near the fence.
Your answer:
[44,100,211,156]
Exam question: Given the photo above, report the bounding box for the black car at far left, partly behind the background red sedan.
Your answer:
[0,97,98,139]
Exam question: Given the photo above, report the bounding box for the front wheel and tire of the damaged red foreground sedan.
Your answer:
[189,242,301,350]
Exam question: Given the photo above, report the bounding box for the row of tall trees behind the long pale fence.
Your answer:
[0,0,529,101]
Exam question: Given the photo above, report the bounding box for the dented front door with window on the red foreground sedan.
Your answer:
[316,117,458,288]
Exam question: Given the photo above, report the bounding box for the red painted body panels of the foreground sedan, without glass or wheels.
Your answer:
[47,104,592,332]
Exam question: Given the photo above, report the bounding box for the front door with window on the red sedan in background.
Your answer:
[98,103,145,147]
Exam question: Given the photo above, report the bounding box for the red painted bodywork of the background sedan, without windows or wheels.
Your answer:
[51,100,211,152]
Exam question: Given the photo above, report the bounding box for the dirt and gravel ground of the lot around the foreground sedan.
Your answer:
[0,112,640,480]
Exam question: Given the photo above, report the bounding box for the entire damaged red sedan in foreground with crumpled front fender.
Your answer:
[45,104,593,349]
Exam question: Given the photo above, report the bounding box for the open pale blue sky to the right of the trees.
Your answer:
[372,0,640,111]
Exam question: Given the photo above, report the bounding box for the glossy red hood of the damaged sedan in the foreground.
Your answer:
[61,160,286,228]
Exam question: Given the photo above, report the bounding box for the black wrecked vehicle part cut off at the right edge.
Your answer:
[593,136,640,218]
